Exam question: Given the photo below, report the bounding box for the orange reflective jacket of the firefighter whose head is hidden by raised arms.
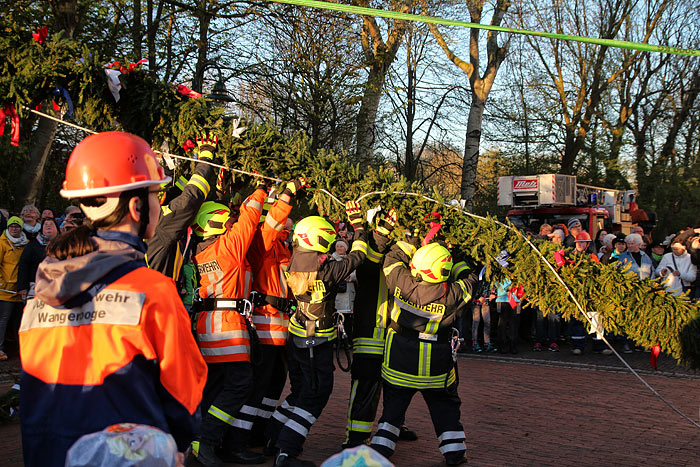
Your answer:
[248,200,292,345]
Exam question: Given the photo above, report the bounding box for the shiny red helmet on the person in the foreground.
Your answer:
[61,131,170,198]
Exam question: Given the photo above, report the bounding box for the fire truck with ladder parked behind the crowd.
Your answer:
[498,174,636,238]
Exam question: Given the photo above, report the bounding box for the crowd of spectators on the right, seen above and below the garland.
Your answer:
[458,218,700,355]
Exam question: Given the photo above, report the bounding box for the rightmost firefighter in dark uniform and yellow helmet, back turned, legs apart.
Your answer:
[371,242,474,465]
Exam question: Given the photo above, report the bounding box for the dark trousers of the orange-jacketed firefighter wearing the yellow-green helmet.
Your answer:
[200,362,253,446]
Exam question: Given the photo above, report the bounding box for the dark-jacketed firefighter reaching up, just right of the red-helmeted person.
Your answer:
[146,133,217,283]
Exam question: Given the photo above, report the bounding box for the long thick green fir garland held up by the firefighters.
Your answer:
[0,20,700,368]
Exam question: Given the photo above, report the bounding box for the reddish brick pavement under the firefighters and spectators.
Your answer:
[0,347,700,467]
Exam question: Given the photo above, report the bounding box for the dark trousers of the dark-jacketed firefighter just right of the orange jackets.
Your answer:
[266,339,335,457]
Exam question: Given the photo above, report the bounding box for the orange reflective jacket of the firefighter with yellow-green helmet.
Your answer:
[194,190,266,363]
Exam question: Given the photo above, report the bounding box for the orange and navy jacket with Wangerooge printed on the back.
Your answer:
[19,267,207,458]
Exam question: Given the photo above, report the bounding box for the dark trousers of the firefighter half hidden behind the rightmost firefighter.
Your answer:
[345,354,382,447]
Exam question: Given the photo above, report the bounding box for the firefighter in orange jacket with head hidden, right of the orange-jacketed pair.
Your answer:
[222,177,308,463]
